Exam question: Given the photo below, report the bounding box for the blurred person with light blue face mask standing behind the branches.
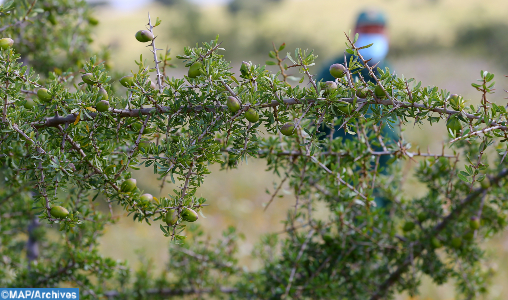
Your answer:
[317,9,399,207]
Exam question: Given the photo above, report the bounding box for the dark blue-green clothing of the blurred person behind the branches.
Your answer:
[317,54,399,207]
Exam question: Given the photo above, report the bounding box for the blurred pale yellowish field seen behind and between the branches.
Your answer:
[83,0,508,299]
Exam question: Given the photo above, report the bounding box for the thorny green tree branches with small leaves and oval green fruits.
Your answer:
[0,0,508,299]
